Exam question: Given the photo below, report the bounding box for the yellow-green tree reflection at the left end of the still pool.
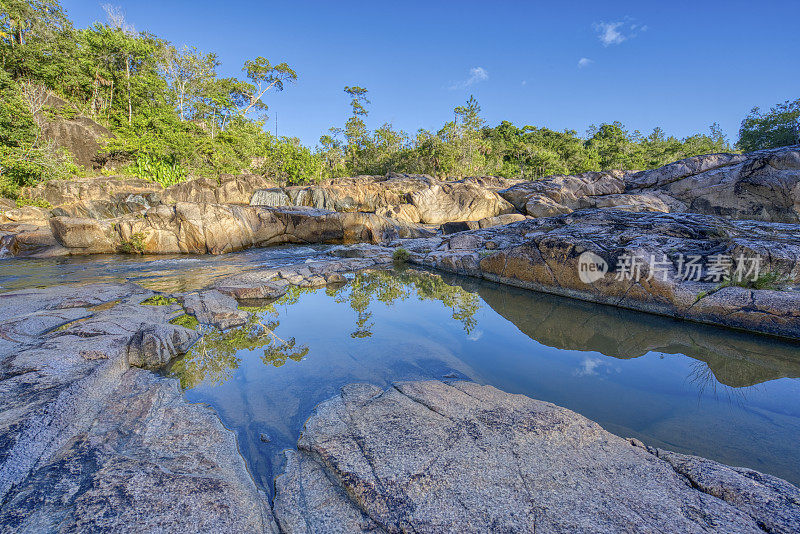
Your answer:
[171,294,309,389]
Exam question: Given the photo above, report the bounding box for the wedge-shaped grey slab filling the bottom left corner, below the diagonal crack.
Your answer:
[0,369,274,533]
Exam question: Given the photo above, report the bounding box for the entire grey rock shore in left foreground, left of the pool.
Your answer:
[0,284,271,532]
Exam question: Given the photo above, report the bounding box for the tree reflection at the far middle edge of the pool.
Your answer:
[328,269,481,338]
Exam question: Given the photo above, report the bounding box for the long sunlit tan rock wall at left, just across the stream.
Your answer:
[39,202,431,254]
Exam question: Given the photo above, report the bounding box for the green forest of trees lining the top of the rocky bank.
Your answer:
[0,0,800,198]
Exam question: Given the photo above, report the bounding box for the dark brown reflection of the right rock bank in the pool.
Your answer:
[445,276,800,387]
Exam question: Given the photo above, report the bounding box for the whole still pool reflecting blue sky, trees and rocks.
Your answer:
[170,271,800,496]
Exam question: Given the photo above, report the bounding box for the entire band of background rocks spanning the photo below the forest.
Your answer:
[0,146,800,257]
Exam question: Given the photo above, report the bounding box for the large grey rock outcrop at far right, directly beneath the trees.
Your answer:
[500,146,800,223]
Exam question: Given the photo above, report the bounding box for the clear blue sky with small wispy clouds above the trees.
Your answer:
[62,0,800,145]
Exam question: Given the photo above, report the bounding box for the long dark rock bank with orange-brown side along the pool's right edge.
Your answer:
[394,210,800,339]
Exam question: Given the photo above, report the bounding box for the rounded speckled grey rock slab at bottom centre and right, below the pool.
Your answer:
[274,381,800,533]
